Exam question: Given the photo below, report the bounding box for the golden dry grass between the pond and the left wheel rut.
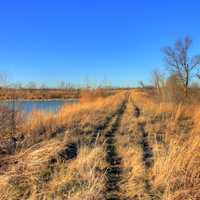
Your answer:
[0,94,125,200]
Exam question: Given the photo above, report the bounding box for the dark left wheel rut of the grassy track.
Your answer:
[105,99,127,200]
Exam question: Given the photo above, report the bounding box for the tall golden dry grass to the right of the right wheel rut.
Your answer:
[133,91,200,200]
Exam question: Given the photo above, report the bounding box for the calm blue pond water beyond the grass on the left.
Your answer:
[0,99,79,113]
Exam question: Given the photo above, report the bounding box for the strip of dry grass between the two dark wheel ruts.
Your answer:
[117,102,149,200]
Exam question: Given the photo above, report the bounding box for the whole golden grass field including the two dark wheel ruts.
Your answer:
[0,90,200,200]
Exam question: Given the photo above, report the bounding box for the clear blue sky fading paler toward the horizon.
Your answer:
[0,0,200,86]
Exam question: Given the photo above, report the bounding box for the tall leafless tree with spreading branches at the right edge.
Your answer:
[163,36,200,96]
